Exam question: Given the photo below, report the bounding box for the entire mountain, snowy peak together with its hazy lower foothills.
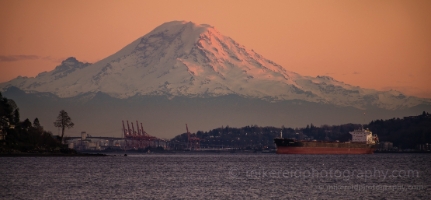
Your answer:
[0,21,431,138]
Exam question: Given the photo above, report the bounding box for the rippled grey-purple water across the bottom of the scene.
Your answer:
[0,154,431,199]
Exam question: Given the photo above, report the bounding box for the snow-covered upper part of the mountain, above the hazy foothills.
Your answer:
[0,21,430,109]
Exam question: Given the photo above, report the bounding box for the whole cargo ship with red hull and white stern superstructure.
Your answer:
[274,128,378,154]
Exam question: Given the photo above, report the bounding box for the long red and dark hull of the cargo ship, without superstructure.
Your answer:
[274,139,375,154]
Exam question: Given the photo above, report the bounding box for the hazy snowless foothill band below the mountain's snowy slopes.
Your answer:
[2,87,431,138]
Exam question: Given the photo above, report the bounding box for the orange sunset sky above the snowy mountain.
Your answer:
[0,0,431,98]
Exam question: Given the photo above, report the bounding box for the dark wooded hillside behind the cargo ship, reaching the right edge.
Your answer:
[171,112,431,149]
